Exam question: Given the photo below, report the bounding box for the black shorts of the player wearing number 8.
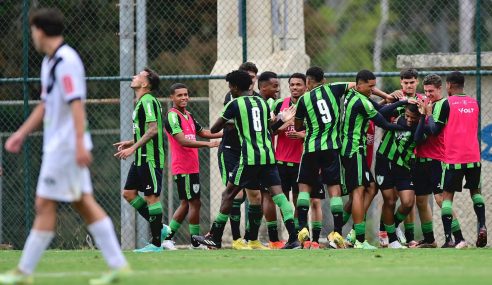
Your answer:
[229,164,281,190]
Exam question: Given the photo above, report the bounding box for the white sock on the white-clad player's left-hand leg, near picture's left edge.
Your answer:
[18,229,55,275]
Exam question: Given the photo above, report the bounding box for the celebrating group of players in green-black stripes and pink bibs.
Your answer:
[121,58,487,252]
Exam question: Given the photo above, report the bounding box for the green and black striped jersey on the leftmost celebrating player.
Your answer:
[133,93,164,168]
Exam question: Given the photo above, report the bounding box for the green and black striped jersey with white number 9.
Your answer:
[295,82,348,152]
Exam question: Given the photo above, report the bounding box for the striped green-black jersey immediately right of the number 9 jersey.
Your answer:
[340,89,378,157]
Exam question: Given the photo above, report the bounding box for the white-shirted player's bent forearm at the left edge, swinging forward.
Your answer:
[5,102,44,153]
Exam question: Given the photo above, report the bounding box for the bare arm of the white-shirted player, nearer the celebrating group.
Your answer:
[70,99,92,166]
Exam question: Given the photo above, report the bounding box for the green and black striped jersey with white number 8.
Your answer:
[221,96,275,165]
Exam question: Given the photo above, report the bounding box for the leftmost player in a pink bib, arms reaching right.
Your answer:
[162,83,222,250]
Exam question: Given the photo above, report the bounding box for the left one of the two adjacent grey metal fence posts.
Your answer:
[120,0,136,249]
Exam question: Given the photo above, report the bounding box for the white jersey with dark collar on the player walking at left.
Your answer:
[41,44,92,153]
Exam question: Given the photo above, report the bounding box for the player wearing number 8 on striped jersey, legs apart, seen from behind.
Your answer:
[193,71,300,249]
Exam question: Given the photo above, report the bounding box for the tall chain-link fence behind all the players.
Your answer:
[0,0,492,248]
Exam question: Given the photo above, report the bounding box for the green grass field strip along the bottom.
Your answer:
[0,249,492,285]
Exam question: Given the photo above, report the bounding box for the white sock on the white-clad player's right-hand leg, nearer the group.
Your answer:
[87,217,127,269]
